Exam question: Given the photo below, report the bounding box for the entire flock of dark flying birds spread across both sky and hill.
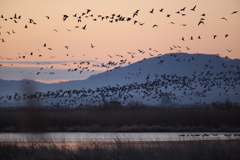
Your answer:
[0,6,240,107]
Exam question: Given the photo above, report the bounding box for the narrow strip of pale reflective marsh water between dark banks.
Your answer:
[0,132,240,142]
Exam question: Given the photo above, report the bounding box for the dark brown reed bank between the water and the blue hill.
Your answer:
[0,101,240,132]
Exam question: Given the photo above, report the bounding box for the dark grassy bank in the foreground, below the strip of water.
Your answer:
[0,140,240,160]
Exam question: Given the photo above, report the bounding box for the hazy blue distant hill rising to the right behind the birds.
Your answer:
[0,53,240,106]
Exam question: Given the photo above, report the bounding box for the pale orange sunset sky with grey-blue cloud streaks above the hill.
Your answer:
[0,0,240,83]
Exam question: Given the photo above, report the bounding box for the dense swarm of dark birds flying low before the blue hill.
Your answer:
[0,54,240,107]
